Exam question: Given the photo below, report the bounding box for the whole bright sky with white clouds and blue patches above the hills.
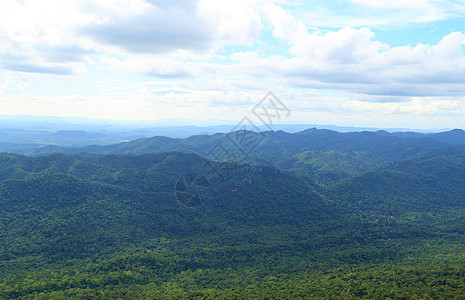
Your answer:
[0,0,465,129]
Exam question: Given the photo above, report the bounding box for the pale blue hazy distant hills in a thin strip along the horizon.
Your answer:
[0,124,465,154]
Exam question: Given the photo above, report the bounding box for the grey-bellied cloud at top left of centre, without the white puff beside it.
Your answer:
[80,1,214,54]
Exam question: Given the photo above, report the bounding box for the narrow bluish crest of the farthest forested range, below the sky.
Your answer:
[23,128,456,157]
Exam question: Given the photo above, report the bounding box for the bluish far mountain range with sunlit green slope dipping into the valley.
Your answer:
[18,128,465,185]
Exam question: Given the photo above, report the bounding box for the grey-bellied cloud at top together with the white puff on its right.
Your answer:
[79,0,261,54]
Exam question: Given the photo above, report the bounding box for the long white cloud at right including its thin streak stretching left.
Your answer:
[99,23,465,98]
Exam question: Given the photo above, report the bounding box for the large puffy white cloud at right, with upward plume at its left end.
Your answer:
[252,3,465,97]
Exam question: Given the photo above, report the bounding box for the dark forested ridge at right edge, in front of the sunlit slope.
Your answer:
[328,154,465,215]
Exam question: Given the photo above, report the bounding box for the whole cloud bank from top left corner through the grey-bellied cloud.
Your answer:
[0,0,262,74]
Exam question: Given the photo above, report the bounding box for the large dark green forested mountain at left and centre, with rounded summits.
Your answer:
[0,153,336,271]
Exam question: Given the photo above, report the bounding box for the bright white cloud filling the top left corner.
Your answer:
[0,0,92,74]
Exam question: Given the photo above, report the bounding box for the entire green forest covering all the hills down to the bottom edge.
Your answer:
[0,129,465,299]
